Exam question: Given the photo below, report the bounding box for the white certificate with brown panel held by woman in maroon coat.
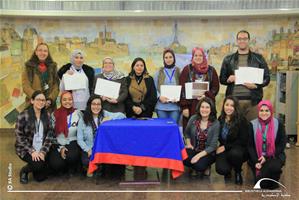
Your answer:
[185,81,210,99]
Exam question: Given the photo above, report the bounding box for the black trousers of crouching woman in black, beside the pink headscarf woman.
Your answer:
[215,147,248,175]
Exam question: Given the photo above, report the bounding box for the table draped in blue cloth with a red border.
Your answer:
[88,118,188,179]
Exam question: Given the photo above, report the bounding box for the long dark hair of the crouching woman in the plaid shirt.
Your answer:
[27,90,49,125]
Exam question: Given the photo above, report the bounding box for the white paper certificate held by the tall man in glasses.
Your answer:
[235,67,264,85]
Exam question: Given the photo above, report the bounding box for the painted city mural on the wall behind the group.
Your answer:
[0,17,299,128]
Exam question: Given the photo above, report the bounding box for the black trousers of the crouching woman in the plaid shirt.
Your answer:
[20,153,48,181]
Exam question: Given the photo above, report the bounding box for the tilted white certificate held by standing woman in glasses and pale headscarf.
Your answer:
[94,78,120,99]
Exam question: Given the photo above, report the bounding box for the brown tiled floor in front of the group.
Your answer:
[0,131,299,200]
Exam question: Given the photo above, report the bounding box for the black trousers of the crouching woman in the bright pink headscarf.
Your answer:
[250,158,284,189]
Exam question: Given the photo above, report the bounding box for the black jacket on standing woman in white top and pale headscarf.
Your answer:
[57,63,94,94]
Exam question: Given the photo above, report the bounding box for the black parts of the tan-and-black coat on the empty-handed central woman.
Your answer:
[126,75,157,117]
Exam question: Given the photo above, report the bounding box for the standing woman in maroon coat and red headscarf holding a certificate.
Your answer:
[180,47,219,130]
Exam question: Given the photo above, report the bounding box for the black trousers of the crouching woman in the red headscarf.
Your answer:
[49,141,80,172]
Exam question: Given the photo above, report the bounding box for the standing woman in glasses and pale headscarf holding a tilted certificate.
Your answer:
[95,57,128,113]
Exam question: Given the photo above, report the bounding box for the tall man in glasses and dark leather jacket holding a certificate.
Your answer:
[220,30,270,121]
